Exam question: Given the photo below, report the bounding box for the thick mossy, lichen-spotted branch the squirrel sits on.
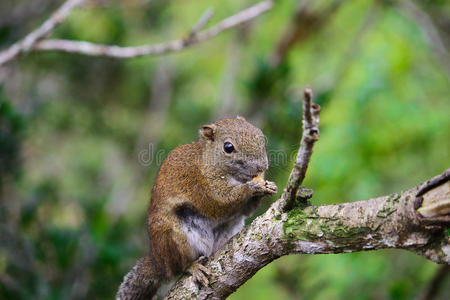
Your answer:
[167,169,450,299]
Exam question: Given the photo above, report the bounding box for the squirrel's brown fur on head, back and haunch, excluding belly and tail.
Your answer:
[126,117,276,298]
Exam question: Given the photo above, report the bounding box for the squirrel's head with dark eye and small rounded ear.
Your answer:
[200,117,268,183]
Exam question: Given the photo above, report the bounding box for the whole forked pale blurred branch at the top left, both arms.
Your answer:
[0,0,273,66]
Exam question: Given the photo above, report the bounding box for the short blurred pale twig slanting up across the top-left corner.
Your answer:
[0,0,84,66]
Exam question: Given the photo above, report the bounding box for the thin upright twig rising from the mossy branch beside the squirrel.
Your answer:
[281,88,320,210]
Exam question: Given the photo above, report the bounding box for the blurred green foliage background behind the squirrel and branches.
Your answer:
[0,0,450,300]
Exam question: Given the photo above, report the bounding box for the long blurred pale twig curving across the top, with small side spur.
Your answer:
[0,0,273,65]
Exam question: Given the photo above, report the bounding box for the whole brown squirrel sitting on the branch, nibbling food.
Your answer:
[117,117,277,300]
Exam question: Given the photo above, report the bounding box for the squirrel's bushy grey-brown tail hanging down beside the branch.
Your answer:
[116,256,161,300]
